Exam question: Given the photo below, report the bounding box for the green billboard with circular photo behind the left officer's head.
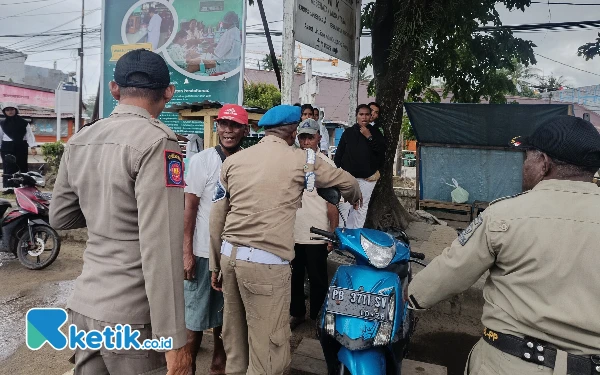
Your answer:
[100,0,247,134]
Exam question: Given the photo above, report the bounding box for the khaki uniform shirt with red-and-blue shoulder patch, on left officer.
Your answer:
[50,105,186,349]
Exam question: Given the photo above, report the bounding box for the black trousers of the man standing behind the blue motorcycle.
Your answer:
[290,244,329,319]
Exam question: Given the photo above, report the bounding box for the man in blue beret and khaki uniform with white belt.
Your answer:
[210,105,361,375]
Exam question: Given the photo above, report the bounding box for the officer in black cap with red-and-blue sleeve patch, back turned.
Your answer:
[50,50,191,375]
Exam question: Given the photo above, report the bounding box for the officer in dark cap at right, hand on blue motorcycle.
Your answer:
[408,116,600,375]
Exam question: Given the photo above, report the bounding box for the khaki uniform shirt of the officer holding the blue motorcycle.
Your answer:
[409,180,600,355]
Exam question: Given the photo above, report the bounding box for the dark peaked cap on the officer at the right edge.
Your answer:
[511,116,600,168]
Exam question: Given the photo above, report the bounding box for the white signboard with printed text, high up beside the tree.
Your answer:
[294,0,360,64]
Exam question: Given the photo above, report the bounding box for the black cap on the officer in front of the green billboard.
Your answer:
[115,49,171,89]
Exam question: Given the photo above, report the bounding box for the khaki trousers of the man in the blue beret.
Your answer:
[221,246,292,375]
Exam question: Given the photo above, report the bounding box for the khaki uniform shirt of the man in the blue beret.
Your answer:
[210,136,360,270]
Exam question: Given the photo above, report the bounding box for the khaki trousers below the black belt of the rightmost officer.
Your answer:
[465,339,567,375]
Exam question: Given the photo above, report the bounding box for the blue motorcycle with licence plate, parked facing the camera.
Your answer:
[310,188,425,375]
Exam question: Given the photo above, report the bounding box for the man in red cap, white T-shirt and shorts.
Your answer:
[183,104,248,374]
